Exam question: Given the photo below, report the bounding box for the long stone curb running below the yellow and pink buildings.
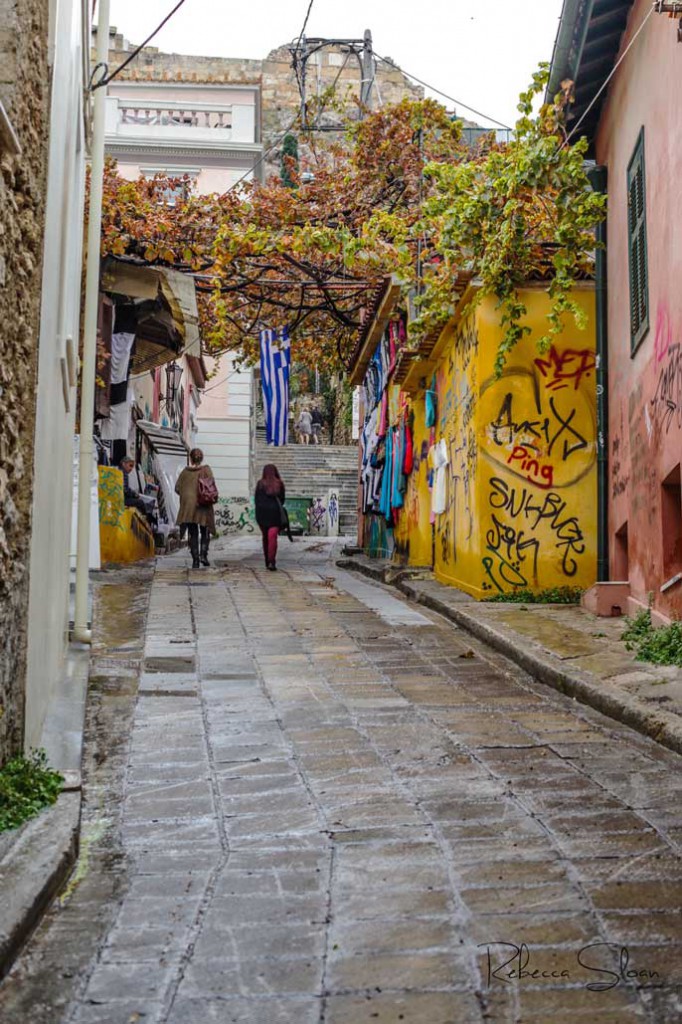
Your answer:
[336,558,682,754]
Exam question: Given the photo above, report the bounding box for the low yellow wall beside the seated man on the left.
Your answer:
[99,466,155,563]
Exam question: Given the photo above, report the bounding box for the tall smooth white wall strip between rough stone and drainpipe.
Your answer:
[25,0,89,749]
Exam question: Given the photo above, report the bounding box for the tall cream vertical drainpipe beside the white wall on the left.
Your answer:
[74,0,110,643]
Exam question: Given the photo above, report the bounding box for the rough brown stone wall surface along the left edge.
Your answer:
[0,0,49,764]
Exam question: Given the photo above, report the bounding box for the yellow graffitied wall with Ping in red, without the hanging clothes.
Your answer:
[430,289,597,598]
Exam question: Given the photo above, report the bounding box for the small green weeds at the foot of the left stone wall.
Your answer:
[0,750,63,833]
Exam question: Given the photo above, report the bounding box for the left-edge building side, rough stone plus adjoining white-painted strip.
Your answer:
[0,0,89,763]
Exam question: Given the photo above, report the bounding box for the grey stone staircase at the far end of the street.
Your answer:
[255,428,357,537]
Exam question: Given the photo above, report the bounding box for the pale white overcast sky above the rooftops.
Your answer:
[106,0,562,126]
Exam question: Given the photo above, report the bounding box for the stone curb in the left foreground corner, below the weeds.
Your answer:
[0,792,81,979]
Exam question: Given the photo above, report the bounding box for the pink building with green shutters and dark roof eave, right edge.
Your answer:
[550,0,682,618]
